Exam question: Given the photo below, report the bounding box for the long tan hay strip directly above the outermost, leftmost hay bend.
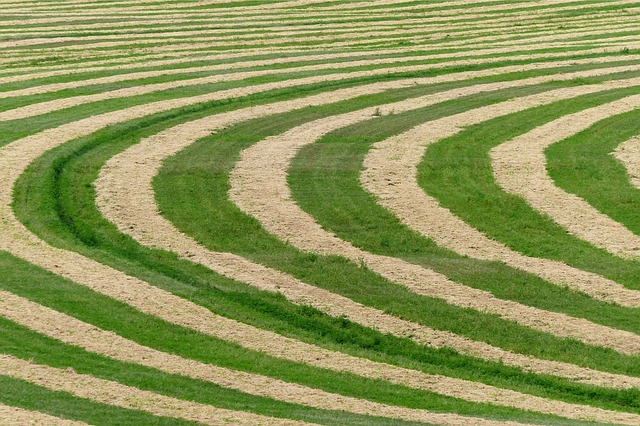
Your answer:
[5,55,640,122]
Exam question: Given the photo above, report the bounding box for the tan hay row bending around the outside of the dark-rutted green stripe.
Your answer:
[3,75,600,420]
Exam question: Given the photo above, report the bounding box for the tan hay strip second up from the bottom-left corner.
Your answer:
[0,354,308,425]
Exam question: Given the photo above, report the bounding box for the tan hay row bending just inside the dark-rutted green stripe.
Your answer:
[95,66,638,387]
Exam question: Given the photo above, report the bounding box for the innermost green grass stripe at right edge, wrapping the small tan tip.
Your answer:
[545,111,640,234]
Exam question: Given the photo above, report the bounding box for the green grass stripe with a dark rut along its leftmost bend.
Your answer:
[16,70,640,412]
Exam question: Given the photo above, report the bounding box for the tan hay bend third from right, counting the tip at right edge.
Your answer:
[360,86,640,308]
